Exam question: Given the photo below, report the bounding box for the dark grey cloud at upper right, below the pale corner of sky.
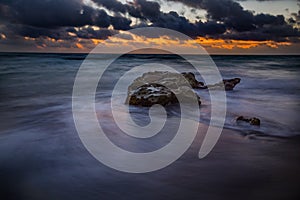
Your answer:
[168,0,299,41]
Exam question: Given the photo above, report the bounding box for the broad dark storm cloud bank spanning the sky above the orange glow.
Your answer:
[0,0,300,49]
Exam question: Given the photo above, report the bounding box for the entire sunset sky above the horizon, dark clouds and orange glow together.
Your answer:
[0,0,300,54]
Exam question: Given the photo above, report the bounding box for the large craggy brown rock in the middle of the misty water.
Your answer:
[126,71,201,107]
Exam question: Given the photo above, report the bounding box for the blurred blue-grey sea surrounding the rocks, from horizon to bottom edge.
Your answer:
[0,53,300,200]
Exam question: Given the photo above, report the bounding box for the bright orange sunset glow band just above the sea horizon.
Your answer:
[21,32,295,53]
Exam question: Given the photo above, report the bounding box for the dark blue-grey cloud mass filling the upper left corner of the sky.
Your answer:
[0,0,131,42]
